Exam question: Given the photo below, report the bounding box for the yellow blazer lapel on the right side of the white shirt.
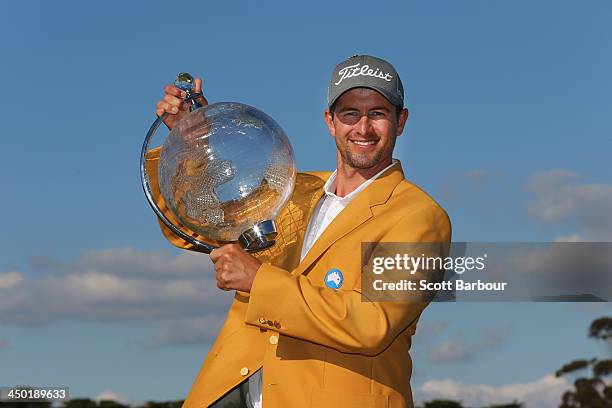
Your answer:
[292,161,404,275]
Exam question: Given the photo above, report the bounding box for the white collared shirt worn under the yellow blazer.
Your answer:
[247,159,399,408]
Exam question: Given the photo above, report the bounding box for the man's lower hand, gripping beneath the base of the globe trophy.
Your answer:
[210,244,261,292]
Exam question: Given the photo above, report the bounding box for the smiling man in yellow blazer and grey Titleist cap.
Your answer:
[147,55,451,408]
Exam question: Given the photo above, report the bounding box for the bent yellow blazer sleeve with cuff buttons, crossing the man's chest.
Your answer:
[245,205,451,355]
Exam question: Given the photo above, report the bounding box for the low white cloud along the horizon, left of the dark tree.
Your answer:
[415,374,571,408]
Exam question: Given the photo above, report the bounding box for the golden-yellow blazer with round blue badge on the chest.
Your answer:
[147,151,451,408]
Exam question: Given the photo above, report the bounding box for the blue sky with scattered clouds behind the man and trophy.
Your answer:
[0,0,612,402]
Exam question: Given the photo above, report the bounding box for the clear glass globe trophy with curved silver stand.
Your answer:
[140,73,296,253]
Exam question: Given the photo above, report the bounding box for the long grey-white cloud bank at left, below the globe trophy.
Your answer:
[0,249,232,344]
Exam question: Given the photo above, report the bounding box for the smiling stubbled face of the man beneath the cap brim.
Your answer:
[325,88,408,174]
